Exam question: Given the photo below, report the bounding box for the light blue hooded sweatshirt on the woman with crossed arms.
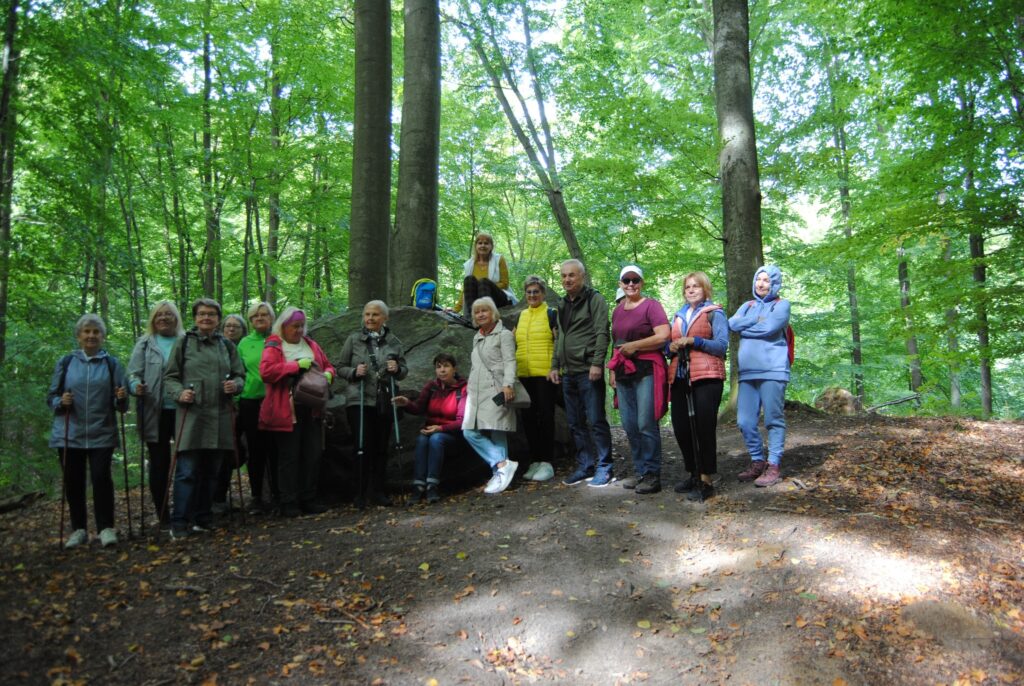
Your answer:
[729,265,790,382]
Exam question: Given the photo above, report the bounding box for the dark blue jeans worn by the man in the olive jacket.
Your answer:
[562,372,611,472]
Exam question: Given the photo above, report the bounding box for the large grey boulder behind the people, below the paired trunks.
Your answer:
[309,305,568,498]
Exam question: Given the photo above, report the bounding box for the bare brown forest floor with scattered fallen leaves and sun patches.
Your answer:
[0,412,1024,686]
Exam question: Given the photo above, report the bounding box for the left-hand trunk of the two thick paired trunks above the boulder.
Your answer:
[348,0,391,307]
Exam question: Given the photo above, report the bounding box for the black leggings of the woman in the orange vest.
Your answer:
[672,379,724,475]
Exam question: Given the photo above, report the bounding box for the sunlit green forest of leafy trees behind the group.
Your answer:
[0,0,1024,492]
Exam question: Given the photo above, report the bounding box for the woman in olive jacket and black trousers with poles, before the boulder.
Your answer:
[338,300,409,509]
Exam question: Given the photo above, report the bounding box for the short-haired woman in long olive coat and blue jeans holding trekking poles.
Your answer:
[164,298,246,539]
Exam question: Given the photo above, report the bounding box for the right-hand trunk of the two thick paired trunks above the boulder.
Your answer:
[389,0,441,304]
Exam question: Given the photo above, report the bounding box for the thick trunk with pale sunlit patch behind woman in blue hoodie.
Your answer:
[714,0,764,397]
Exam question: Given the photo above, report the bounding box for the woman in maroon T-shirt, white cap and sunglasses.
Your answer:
[606,264,669,495]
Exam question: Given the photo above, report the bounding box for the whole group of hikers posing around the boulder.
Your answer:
[47,234,790,548]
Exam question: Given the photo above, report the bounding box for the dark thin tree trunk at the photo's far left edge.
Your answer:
[0,0,18,366]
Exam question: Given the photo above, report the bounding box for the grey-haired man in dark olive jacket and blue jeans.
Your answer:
[548,260,614,487]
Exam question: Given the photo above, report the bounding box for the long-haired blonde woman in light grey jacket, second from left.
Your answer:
[128,300,185,524]
